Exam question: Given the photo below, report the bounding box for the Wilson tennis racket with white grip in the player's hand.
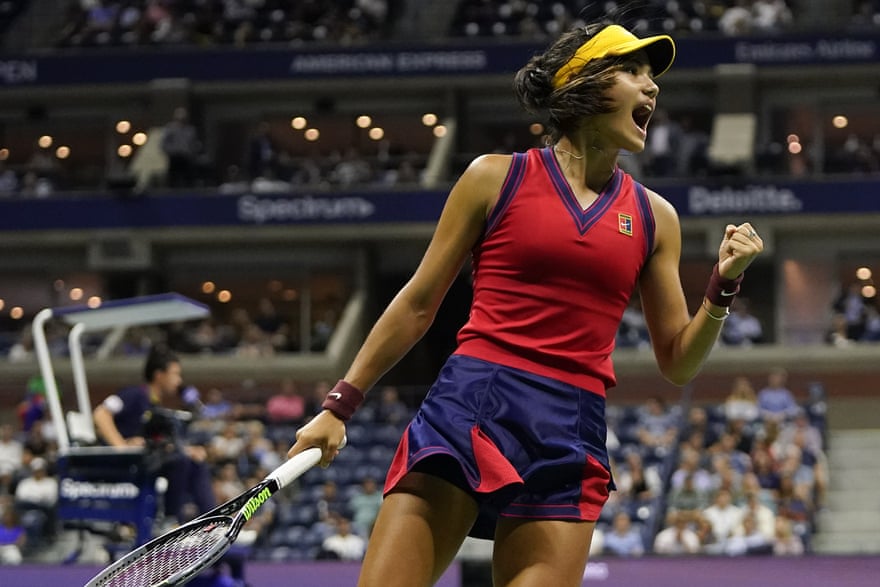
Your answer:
[85,440,345,587]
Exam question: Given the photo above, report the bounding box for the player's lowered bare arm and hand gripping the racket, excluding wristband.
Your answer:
[289,155,511,464]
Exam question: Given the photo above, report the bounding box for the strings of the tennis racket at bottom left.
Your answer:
[94,518,232,587]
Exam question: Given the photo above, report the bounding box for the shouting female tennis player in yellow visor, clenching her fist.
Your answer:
[290,20,763,587]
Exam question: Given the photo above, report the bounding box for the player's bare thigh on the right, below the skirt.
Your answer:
[492,517,596,587]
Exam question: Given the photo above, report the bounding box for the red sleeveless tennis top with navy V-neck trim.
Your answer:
[456,148,655,395]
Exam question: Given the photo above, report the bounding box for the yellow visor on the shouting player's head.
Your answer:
[553,24,675,89]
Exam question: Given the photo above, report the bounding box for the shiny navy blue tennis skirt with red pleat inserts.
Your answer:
[385,355,614,538]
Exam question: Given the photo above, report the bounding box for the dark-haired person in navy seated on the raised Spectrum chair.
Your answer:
[92,346,216,523]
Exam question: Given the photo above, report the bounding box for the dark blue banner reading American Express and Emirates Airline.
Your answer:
[0,33,880,87]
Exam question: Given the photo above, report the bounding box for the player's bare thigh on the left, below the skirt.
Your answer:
[358,472,477,587]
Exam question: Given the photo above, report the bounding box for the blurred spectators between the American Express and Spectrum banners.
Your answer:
[0,99,880,199]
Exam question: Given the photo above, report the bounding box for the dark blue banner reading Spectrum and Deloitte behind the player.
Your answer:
[0,178,880,231]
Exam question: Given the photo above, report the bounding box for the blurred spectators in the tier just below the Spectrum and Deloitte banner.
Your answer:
[10,274,880,363]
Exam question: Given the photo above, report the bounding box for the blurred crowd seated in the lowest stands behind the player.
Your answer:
[0,369,828,564]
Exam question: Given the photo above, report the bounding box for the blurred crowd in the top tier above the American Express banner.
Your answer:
[46,0,880,47]
